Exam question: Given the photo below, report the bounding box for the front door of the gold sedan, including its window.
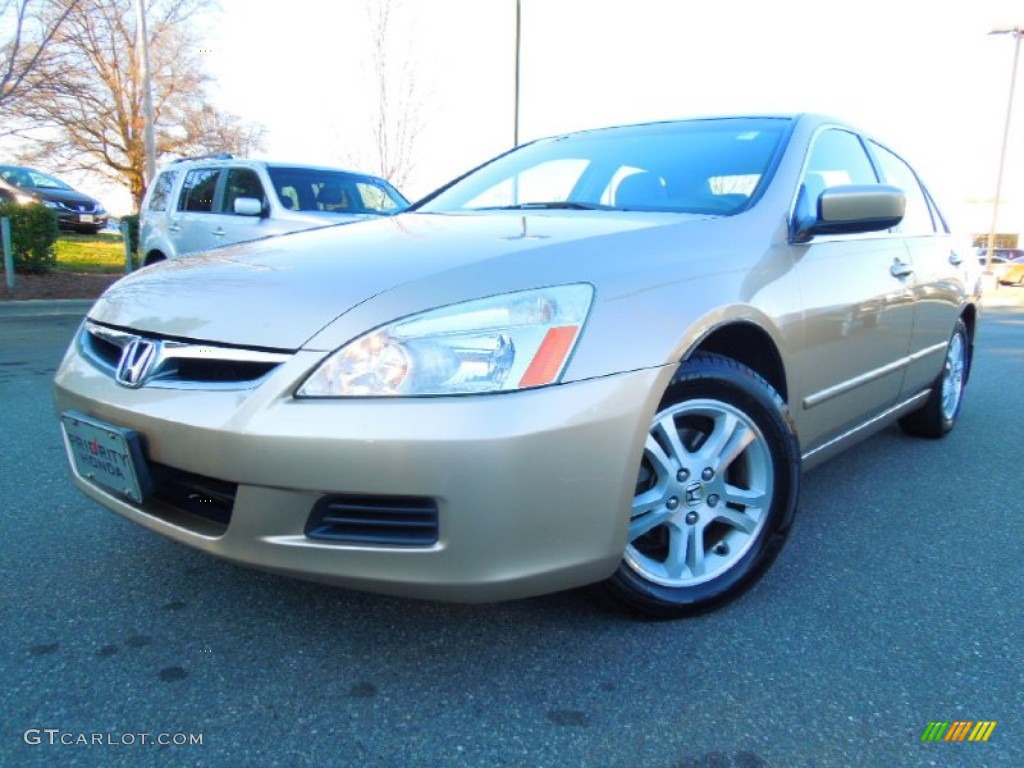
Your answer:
[791,128,914,451]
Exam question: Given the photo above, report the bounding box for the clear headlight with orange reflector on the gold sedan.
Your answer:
[296,285,594,397]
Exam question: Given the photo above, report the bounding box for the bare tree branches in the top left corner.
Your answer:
[0,0,80,126]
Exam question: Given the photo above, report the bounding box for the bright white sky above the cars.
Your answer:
[41,0,1024,237]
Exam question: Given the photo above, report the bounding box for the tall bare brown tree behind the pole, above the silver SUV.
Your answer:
[22,0,263,208]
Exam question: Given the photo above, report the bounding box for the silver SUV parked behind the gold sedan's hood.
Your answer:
[139,155,409,264]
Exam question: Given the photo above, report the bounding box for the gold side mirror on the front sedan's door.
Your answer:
[790,184,906,243]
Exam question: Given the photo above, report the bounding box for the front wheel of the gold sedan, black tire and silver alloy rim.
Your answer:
[598,353,801,617]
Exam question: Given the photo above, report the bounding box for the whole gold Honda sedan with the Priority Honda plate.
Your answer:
[55,115,979,616]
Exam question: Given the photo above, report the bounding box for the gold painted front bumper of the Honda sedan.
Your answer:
[55,346,674,602]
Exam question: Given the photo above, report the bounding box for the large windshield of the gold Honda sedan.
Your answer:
[417,118,790,215]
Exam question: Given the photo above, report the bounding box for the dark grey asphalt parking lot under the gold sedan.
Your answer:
[0,289,1024,768]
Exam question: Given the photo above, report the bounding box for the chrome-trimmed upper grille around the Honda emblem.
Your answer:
[79,321,291,389]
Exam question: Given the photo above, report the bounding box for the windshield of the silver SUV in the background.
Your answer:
[267,167,409,214]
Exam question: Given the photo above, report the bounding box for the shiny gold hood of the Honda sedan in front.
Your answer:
[89,212,712,349]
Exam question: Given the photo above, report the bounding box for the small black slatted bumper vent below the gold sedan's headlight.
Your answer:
[305,496,438,547]
